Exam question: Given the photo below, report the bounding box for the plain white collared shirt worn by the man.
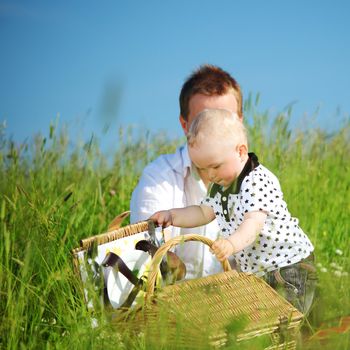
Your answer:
[130,145,222,278]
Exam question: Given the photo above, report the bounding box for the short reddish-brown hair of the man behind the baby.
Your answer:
[179,64,243,121]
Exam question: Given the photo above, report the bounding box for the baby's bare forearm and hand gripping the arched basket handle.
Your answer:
[211,211,267,261]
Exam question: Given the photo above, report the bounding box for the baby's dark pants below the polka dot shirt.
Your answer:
[263,253,317,315]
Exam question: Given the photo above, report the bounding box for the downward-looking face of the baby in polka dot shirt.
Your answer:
[188,139,246,187]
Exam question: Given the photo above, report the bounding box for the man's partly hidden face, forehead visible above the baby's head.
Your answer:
[180,91,238,135]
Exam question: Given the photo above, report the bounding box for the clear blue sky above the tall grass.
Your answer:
[0,0,350,149]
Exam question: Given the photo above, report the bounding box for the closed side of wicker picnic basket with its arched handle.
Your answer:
[122,234,303,349]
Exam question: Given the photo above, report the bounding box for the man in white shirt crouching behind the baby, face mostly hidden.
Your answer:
[130,65,243,278]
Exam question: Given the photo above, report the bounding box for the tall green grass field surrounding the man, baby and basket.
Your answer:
[0,105,350,349]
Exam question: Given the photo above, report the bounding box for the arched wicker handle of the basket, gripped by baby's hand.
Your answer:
[146,234,232,300]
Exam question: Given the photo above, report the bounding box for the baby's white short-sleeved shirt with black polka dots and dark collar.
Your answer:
[202,153,314,276]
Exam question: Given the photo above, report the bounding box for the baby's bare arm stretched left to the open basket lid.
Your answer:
[150,205,215,227]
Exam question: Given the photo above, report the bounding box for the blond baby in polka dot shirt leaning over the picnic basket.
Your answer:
[151,109,315,313]
